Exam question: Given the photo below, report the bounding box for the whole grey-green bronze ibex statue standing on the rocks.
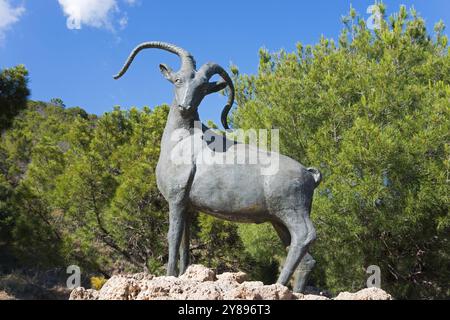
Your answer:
[114,42,322,292]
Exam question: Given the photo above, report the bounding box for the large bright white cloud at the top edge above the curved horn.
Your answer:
[58,0,138,31]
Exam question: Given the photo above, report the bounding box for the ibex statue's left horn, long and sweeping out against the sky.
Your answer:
[114,41,196,80]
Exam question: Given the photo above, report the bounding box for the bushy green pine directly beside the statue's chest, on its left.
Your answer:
[51,107,171,272]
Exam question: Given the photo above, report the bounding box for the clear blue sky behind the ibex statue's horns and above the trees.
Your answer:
[0,0,450,123]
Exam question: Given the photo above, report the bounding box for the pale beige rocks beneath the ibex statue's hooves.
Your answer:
[70,265,392,300]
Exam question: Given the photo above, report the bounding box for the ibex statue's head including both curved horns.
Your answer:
[114,42,234,129]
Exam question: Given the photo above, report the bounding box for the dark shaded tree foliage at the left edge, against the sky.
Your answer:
[0,65,30,133]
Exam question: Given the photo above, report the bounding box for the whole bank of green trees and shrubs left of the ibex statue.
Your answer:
[0,102,168,274]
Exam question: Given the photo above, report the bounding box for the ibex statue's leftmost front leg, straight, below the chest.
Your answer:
[167,203,186,277]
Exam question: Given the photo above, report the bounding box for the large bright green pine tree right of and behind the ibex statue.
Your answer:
[232,7,450,298]
